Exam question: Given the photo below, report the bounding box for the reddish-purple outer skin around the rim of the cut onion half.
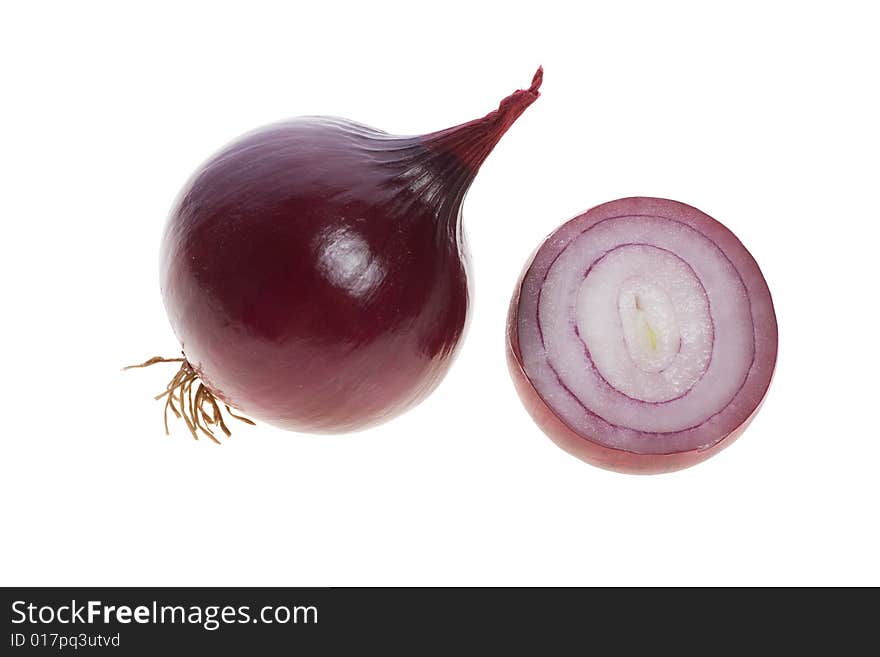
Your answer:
[506,197,778,474]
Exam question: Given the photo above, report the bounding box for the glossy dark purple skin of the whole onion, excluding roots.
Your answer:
[160,70,541,433]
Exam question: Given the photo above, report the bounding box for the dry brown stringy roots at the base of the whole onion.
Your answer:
[122,356,254,445]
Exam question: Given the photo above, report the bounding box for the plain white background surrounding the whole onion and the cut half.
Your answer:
[0,1,880,585]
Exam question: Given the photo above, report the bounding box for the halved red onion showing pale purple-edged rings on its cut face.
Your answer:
[507,198,777,473]
